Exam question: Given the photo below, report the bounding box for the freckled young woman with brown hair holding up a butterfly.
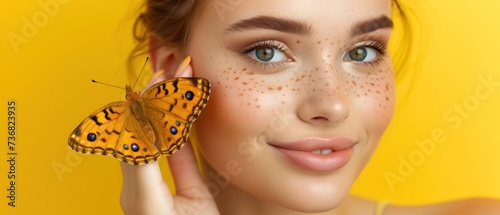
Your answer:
[121,0,500,215]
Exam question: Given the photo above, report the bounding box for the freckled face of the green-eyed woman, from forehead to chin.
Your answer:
[187,0,394,212]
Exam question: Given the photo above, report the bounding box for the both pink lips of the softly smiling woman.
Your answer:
[271,137,356,172]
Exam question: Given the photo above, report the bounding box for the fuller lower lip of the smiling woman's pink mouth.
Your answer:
[274,147,353,172]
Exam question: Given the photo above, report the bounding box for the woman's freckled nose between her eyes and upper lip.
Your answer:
[297,66,350,126]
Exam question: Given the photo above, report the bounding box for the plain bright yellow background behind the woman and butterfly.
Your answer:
[0,0,500,214]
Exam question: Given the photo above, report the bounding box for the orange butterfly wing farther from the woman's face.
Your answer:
[68,101,160,165]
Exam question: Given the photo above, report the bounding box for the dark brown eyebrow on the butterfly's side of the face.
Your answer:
[226,16,312,35]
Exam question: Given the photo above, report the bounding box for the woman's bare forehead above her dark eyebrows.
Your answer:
[195,0,391,34]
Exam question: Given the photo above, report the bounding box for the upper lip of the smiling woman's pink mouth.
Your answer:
[270,137,356,152]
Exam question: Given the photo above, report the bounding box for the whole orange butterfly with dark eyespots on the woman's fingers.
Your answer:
[68,75,210,165]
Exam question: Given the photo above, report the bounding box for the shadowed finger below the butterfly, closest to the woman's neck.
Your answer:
[168,142,211,199]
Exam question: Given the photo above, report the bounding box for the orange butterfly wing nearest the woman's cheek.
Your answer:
[142,78,210,155]
